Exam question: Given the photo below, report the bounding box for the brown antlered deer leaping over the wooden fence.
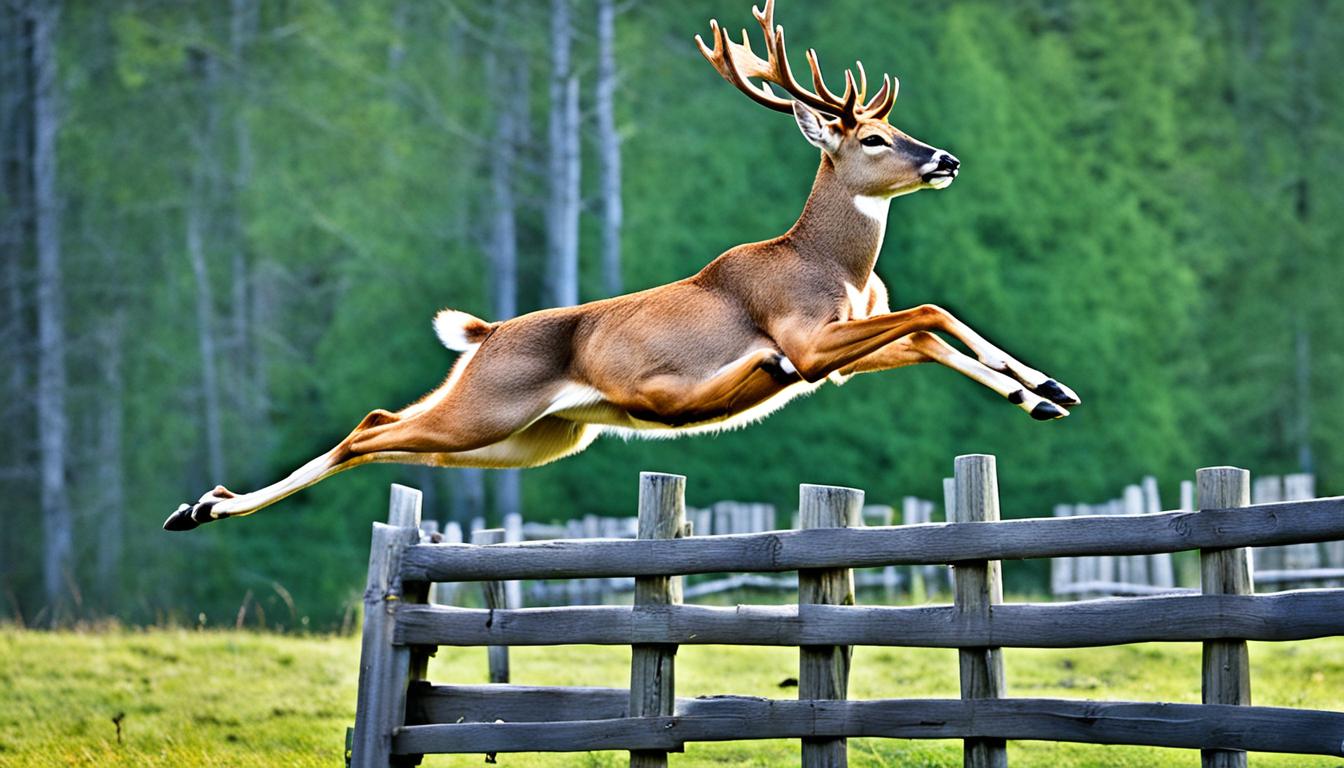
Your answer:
[164,0,1081,531]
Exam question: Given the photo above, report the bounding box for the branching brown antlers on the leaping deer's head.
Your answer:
[695,0,899,128]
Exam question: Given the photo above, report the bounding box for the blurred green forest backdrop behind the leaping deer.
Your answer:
[0,0,1344,629]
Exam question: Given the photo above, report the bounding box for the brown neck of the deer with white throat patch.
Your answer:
[785,156,891,279]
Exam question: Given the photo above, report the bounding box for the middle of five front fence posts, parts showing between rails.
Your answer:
[798,486,863,768]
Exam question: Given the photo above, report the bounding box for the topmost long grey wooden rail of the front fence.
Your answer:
[402,498,1344,581]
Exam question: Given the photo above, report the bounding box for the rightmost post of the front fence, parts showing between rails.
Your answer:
[1195,467,1251,768]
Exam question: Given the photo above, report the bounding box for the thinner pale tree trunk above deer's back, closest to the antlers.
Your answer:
[595,0,621,296]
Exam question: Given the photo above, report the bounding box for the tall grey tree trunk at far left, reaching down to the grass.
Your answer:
[28,3,74,623]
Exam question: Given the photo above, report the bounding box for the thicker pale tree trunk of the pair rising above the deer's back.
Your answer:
[546,0,579,307]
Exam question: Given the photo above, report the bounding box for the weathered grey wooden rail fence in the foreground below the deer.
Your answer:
[352,456,1344,767]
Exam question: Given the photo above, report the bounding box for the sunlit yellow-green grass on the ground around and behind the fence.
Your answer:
[0,629,1344,768]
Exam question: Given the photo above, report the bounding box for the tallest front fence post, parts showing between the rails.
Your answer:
[953,455,1008,768]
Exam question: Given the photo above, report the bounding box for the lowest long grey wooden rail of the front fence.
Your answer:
[394,697,1344,757]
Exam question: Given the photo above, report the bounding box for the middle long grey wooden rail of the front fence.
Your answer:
[396,589,1344,648]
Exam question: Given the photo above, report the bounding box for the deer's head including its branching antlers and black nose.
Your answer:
[695,0,961,198]
